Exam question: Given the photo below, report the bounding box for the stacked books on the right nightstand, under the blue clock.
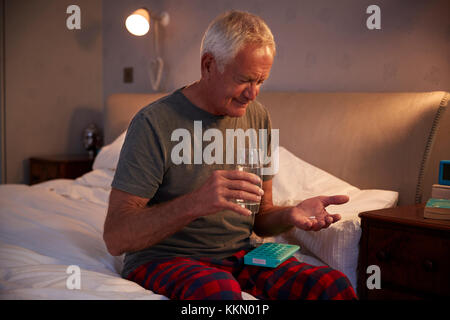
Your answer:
[423,184,450,220]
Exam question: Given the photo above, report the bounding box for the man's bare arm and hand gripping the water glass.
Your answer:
[103,170,262,256]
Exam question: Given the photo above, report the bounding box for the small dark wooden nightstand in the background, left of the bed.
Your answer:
[30,155,94,184]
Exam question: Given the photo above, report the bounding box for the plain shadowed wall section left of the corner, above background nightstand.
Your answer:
[5,0,103,183]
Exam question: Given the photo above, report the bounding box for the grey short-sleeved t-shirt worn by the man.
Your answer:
[112,89,272,277]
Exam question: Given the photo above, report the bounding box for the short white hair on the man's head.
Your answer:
[200,10,276,72]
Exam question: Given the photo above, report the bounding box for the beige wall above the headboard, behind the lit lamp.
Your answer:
[103,0,450,97]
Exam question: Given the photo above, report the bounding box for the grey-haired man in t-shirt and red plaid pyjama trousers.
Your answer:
[104,11,356,300]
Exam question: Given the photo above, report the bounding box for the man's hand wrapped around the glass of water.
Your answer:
[191,170,264,216]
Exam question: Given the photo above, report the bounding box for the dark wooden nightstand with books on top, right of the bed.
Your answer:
[358,204,450,300]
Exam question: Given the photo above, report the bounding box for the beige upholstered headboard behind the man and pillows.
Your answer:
[104,92,450,204]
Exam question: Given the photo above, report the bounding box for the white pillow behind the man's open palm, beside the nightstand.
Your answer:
[264,147,398,288]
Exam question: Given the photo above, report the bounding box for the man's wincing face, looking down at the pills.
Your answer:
[204,45,273,117]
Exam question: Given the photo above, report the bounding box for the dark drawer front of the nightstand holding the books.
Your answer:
[367,225,450,295]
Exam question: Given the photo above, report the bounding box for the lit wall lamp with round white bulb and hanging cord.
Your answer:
[125,8,170,91]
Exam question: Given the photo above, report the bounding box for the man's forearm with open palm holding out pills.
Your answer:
[254,180,349,237]
